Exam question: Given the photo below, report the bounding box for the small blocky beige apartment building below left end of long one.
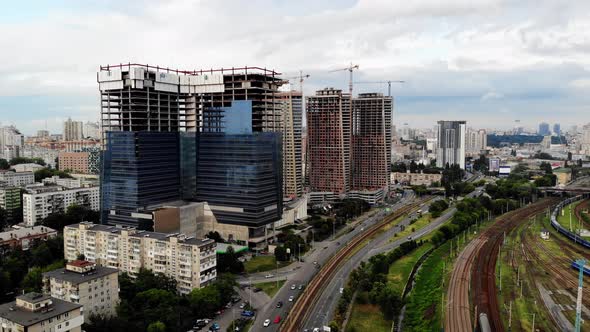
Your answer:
[43,260,119,317]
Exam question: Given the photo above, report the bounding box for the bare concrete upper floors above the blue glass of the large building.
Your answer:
[97,64,283,144]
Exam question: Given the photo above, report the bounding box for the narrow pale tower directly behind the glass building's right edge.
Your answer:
[278,91,303,198]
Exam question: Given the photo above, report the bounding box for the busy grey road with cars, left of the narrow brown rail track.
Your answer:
[250,192,415,332]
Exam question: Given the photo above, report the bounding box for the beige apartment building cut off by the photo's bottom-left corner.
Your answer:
[0,293,84,332]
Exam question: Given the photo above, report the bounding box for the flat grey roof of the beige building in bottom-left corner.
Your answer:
[0,293,82,326]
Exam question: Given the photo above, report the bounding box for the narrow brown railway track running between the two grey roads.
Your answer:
[280,198,432,331]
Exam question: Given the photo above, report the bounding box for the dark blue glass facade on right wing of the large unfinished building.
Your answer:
[195,133,283,227]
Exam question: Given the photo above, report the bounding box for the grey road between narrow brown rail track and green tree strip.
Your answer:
[304,188,482,331]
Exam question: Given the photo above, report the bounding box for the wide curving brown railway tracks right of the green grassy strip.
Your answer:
[445,199,555,331]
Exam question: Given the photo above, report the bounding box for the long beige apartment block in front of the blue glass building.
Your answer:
[64,222,217,294]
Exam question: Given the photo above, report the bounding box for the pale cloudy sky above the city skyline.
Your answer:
[0,0,590,134]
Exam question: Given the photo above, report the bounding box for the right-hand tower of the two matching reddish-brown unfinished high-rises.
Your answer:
[351,93,392,203]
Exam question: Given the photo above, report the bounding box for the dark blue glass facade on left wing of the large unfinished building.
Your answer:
[101,131,181,229]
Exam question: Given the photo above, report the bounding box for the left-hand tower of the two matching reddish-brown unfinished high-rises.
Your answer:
[306,88,352,197]
